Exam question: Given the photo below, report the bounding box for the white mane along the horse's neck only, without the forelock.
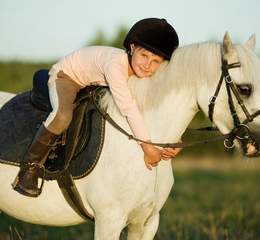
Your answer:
[100,43,221,111]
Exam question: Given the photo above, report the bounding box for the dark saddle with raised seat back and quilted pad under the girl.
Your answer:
[0,69,106,180]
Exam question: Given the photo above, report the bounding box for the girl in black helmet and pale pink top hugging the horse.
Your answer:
[12,18,183,197]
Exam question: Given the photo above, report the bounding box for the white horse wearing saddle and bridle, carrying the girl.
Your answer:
[0,34,260,240]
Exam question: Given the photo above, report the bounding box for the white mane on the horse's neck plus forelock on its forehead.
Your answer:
[103,42,260,118]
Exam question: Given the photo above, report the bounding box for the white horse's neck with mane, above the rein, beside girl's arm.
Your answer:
[101,44,220,142]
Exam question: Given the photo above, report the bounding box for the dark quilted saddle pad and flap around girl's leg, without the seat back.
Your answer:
[0,87,105,180]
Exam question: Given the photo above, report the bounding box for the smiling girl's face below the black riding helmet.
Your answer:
[130,44,164,78]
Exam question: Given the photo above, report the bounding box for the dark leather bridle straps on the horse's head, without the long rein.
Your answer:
[208,57,260,151]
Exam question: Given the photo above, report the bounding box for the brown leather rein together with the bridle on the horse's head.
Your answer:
[91,54,260,148]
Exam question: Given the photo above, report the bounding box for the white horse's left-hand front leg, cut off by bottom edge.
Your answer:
[95,208,127,240]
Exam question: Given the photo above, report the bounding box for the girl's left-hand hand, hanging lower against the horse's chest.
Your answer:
[141,143,161,170]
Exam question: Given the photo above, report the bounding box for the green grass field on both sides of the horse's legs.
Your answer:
[0,163,260,240]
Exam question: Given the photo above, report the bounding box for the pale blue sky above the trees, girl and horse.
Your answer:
[0,0,260,61]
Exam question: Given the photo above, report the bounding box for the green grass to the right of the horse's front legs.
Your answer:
[157,167,260,240]
